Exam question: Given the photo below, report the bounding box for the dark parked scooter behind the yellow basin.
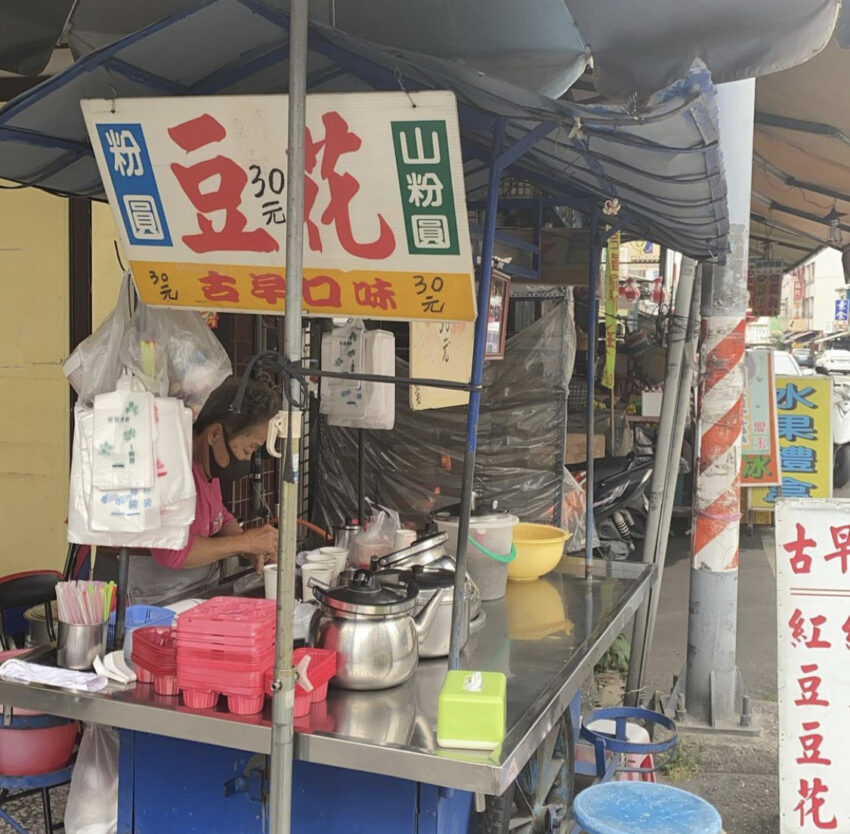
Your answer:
[567,455,653,561]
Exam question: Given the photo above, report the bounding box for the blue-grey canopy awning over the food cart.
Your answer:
[0,0,728,257]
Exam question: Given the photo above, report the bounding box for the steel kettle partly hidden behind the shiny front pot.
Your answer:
[377,565,478,658]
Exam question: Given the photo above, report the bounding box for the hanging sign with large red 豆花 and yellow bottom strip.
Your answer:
[82,91,475,321]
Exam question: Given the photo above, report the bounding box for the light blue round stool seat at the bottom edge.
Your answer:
[573,782,723,834]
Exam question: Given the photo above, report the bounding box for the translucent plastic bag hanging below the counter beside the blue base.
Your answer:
[65,724,118,834]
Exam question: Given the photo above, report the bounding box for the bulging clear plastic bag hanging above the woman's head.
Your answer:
[121,303,233,417]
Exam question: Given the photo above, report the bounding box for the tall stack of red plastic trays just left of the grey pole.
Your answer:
[177,597,275,715]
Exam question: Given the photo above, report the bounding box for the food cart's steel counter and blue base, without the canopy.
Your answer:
[0,557,653,834]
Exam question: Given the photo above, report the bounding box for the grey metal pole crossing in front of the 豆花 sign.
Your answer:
[269,0,308,834]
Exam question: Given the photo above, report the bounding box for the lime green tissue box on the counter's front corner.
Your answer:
[437,670,508,750]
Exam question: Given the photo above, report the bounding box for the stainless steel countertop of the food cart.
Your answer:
[0,557,654,794]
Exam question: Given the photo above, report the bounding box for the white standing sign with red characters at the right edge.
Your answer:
[776,498,850,834]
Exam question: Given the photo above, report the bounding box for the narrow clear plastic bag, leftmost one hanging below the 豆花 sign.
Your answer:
[62,273,134,405]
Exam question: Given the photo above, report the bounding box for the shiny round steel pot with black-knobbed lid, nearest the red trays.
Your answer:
[308,570,439,689]
